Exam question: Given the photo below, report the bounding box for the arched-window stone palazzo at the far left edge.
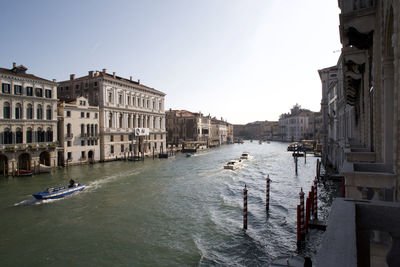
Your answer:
[0,63,57,174]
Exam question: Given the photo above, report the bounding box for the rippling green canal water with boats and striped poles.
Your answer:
[0,141,335,266]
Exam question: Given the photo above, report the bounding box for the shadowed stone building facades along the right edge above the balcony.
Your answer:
[320,0,400,201]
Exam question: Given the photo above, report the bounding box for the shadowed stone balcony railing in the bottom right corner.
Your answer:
[315,199,400,267]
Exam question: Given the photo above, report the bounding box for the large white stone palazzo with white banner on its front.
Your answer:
[58,69,166,161]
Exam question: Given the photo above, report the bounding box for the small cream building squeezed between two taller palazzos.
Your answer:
[58,97,100,166]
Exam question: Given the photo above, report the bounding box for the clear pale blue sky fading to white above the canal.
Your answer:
[0,0,341,124]
